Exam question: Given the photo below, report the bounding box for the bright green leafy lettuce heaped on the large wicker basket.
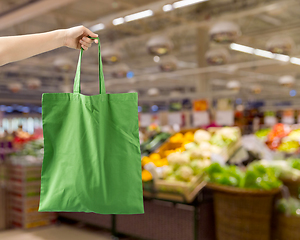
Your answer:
[205,162,282,190]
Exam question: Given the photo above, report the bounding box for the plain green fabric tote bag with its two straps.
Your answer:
[39,39,144,214]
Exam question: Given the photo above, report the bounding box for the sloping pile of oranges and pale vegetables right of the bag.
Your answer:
[142,127,239,183]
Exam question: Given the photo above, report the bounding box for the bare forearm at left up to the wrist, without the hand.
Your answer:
[0,30,65,66]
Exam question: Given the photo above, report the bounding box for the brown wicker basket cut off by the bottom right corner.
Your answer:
[276,214,300,240]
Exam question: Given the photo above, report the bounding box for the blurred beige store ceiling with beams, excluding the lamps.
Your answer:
[0,0,300,107]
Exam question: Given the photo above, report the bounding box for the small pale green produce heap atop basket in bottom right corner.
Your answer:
[277,198,300,217]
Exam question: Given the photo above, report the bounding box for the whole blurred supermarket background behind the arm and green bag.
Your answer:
[0,0,300,240]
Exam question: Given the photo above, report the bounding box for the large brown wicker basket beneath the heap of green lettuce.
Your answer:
[207,183,279,240]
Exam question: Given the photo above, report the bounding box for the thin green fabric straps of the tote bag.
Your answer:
[73,37,106,94]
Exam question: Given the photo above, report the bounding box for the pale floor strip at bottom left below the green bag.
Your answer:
[0,225,111,240]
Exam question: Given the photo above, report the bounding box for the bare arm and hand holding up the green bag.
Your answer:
[0,26,98,66]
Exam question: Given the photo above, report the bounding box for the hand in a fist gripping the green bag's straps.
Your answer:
[64,26,98,50]
